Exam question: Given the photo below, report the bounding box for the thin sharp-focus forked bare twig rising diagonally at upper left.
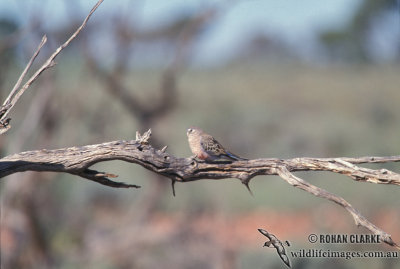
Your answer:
[0,0,103,134]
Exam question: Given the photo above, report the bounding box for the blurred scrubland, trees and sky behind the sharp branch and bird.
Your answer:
[0,0,400,269]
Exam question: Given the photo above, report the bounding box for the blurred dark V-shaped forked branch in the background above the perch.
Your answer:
[85,8,218,126]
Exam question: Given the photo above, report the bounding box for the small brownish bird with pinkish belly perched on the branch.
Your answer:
[186,127,247,162]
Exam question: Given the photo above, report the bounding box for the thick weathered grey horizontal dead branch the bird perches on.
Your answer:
[0,130,400,247]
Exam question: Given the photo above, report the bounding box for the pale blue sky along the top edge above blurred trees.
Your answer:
[0,0,374,65]
